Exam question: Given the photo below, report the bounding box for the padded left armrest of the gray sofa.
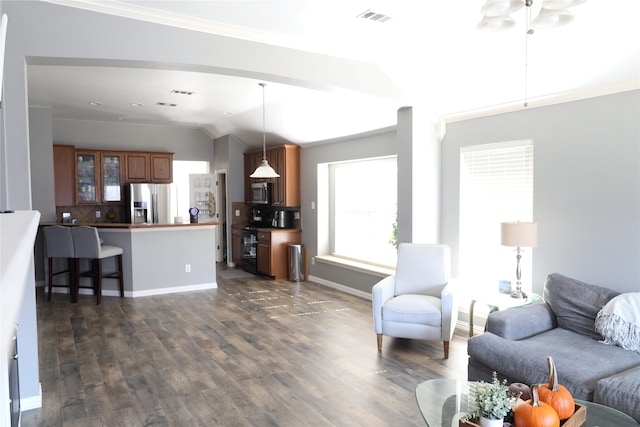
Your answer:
[487,303,557,340]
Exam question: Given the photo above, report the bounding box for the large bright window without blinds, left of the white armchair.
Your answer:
[329,156,398,266]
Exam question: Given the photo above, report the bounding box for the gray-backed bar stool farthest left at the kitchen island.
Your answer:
[42,225,76,302]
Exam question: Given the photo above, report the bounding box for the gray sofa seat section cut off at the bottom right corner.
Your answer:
[593,366,640,423]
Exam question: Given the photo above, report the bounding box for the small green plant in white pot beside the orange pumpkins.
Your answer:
[464,372,519,427]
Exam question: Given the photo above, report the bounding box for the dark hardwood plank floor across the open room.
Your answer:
[22,266,467,427]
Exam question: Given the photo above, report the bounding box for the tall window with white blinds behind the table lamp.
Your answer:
[459,140,533,290]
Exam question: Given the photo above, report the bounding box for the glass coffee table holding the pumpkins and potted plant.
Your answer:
[416,379,640,427]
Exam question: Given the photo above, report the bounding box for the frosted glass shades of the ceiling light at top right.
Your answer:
[476,0,587,34]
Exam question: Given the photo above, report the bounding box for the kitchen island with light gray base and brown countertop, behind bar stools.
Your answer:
[40,222,219,297]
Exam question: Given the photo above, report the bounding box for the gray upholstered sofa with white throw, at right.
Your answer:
[468,273,640,422]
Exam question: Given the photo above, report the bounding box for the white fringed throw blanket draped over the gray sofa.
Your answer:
[595,292,640,353]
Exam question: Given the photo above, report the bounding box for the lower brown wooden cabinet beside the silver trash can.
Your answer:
[257,229,302,280]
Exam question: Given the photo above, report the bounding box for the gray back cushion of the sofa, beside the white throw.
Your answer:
[544,273,619,340]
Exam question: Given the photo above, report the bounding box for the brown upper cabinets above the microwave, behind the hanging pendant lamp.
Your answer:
[244,144,300,207]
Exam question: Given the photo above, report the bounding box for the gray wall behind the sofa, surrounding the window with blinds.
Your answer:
[441,91,640,292]
